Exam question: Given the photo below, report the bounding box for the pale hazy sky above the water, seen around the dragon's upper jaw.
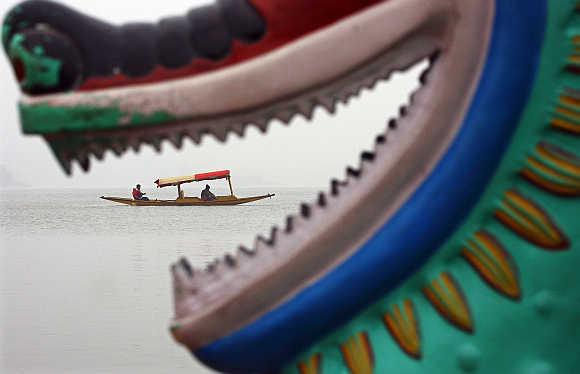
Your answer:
[0,0,420,188]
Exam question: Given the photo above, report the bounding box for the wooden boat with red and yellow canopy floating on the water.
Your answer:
[101,170,275,206]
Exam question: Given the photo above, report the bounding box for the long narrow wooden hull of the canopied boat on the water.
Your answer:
[101,194,275,206]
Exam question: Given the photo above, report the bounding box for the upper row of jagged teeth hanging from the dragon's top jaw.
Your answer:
[46,55,436,175]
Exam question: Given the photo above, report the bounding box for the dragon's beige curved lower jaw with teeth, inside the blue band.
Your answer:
[172,0,491,360]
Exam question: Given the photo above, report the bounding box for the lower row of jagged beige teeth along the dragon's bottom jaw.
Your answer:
[171,57,433,323]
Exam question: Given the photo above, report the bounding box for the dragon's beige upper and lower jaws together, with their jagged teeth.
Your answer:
[2,0,493,370]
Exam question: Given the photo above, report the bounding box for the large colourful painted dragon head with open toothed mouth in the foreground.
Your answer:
[2,0,580,374]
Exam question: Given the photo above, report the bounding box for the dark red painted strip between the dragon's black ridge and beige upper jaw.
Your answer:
[79,0,388,91]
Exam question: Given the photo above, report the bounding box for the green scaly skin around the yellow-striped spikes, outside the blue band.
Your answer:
[285,1,580,374]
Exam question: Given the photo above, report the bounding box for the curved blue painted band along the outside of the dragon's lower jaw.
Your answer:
[194,0,547,373]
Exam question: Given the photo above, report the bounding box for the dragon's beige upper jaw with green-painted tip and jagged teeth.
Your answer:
[12,0,453,173]
